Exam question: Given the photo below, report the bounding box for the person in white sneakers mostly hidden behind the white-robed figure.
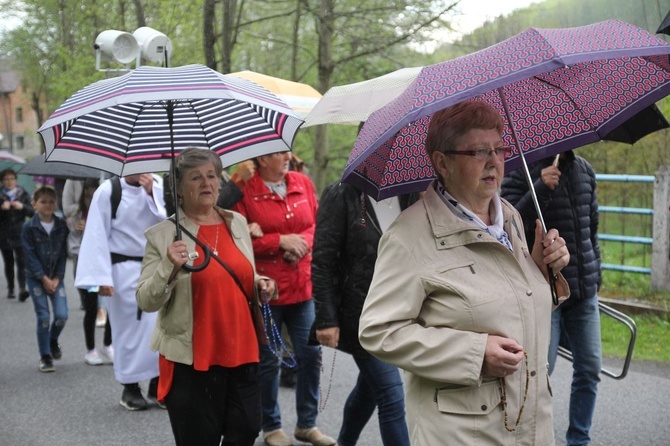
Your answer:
[66,179,114,365]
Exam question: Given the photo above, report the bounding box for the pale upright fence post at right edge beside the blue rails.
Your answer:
[651,166,670,291]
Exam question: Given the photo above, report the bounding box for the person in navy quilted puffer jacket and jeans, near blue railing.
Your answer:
[501,151,602,446]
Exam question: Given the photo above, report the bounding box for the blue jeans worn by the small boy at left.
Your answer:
[27,278,67,356]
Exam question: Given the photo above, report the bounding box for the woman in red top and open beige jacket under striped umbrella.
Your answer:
[137,148,276,446]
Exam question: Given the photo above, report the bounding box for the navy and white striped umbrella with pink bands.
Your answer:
[38,65,303,175]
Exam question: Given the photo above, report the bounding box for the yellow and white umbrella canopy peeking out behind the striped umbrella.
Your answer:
[229,71,321,119]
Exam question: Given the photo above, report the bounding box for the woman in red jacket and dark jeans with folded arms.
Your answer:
[234,152,336,446]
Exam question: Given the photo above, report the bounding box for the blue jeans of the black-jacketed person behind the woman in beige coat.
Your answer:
[337,355,409,446]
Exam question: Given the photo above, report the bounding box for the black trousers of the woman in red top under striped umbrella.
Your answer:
[165,363,261,446]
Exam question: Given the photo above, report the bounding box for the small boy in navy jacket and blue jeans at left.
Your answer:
[21,186,69,372]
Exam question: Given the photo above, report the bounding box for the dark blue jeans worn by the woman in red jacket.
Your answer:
[261,299,321,432]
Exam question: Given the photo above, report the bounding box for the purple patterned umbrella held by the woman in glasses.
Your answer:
[343,20,670,199]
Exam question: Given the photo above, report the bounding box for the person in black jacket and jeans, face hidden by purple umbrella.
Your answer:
[312,183,418,446]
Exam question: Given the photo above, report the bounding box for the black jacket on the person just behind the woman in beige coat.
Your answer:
[310,183,418,356]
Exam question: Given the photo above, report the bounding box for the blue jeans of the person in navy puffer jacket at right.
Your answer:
[549,296,602,446]
